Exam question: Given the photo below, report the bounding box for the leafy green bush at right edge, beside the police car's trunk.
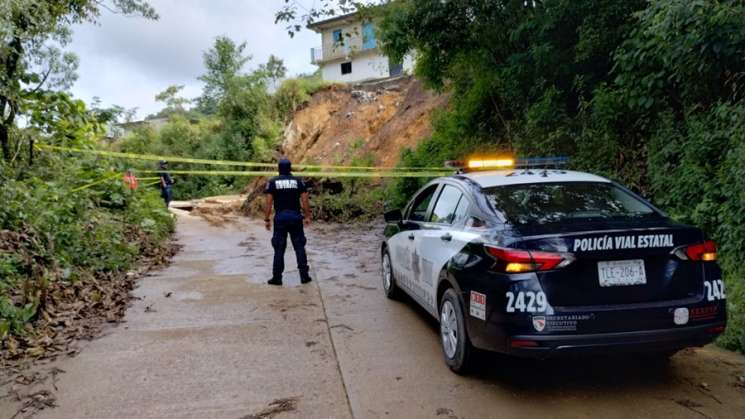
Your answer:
[647,103,745,350]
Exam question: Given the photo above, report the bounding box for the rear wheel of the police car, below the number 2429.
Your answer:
[439,288,474,374]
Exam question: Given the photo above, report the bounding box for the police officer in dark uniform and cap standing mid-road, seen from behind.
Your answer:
[264,159,311,285]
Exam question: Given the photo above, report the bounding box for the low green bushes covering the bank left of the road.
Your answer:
[0,154,174,339]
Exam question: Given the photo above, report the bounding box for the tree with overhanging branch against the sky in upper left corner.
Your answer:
[0,0,158,160]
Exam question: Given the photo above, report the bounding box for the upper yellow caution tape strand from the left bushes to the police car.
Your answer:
[36,144,452,172]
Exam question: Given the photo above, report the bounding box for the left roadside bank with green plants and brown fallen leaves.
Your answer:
[0,148,174,364]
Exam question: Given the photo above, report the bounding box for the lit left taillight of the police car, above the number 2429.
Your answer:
[484,245,574,273]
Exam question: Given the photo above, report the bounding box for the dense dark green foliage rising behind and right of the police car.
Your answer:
[372,0,745,350]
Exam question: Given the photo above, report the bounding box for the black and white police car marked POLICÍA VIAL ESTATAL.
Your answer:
[381,158,726,372]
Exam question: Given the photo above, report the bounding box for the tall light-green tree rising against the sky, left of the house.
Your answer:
[197,36,251,115]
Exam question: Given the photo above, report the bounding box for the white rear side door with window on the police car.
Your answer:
[414,184,470,313]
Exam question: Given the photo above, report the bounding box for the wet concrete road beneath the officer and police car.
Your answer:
[29,216,745,418]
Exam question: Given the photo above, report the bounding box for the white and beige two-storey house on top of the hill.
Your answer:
[308,13,414,83]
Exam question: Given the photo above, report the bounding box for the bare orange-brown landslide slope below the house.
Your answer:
[280,77,447,166]
